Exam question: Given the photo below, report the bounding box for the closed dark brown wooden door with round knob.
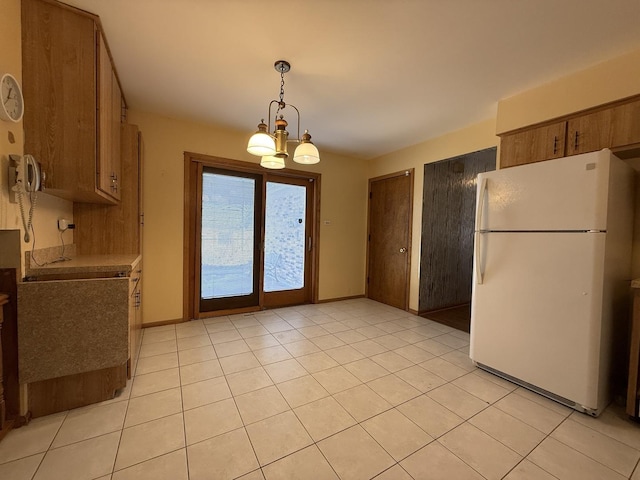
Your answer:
[367,169,413,310]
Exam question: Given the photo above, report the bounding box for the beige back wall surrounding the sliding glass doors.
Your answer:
[129,110,367,323]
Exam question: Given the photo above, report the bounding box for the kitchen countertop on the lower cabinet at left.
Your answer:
[26,254,140,277]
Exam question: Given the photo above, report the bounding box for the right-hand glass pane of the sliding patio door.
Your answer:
[264,182,307,292]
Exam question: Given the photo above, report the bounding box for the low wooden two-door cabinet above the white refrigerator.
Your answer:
[500,97,640,168]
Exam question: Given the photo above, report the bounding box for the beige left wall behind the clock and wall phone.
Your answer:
[0,0,73,274]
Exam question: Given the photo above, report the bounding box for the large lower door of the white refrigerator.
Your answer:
[470,232,609,409]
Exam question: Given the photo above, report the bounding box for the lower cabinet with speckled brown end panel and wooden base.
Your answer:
[18,256,142,417]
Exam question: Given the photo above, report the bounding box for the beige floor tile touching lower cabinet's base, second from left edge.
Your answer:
[51,402,127,448]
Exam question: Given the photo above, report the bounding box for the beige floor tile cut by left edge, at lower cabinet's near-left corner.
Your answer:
[0,412,67,464]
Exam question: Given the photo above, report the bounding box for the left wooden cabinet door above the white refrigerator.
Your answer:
[500,121,567,168]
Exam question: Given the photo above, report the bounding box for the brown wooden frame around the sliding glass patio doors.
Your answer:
[182,152,321,321]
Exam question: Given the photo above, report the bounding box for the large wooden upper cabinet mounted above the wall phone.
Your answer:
[22,0,123,204]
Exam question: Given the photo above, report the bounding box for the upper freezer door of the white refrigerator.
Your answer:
[476,150,617,231]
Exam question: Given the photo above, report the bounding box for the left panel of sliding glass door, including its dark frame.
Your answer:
[200,169,261,311]
